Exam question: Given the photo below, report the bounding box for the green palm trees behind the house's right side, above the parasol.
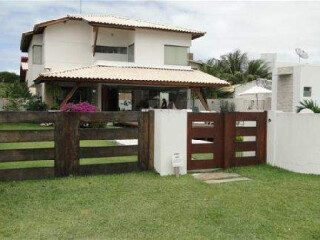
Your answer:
[201,50,271,84]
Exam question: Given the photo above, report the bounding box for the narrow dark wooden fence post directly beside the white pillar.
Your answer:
[138,112,149,170]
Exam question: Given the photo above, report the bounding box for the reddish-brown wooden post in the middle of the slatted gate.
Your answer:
[223,112,236,168]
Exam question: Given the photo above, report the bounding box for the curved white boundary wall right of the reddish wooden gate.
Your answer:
[267,111,320,174]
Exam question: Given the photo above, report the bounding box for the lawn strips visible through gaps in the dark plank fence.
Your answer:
[0,123,138,169]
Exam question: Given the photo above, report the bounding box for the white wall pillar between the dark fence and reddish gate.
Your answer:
[154,109,188,176]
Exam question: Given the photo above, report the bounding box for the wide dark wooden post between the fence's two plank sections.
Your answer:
[54,113,80,177]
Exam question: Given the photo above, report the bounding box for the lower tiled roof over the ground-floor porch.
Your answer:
[35,65,229,87]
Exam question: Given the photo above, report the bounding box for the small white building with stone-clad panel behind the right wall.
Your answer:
[272,64,320,112]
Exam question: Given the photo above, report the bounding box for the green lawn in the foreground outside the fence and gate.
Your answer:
[0,166,320,239]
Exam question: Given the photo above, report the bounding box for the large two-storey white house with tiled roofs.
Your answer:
[20,15,228,111]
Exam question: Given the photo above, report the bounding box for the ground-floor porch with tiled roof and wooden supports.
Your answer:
[35,65,229,111]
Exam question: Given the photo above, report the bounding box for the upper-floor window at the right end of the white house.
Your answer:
[164,45,189,66]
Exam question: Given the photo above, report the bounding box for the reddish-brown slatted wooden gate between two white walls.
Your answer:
[187,112,267,170]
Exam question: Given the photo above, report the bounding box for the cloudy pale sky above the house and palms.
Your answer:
[0,0,320,72]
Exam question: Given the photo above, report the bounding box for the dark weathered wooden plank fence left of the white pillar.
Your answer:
[0,112,149,181]
